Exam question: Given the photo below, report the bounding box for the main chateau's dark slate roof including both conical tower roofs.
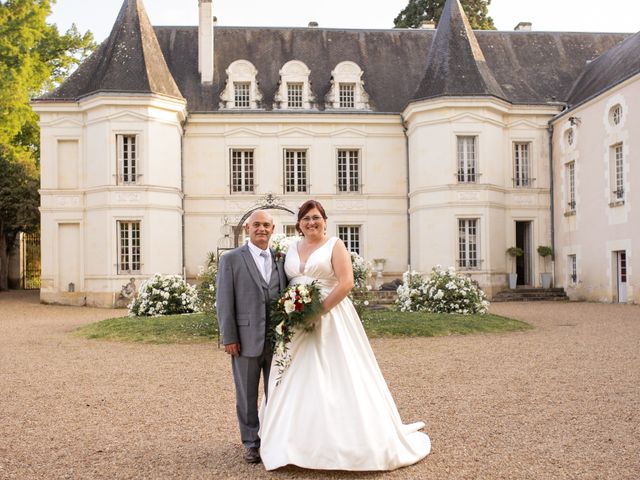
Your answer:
[35,0,638,114]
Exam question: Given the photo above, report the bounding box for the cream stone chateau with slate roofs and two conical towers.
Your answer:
[32,0,640,306]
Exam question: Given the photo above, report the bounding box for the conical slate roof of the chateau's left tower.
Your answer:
[39,0,183,100]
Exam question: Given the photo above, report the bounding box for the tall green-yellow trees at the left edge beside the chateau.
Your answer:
[0,0,95,290]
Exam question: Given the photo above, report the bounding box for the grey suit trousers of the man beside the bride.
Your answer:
[231,348,273,448]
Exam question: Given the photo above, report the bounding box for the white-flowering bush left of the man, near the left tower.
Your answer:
[128,273,198,317]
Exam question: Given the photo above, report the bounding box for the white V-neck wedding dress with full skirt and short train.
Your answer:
[260,237,431,470]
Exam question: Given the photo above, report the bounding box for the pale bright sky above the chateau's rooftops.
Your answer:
[49,0,640,42]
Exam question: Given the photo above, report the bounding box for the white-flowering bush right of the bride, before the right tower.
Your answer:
[396,265,489,315]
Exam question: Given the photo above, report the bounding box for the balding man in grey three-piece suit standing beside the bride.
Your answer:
[216,210,287,463]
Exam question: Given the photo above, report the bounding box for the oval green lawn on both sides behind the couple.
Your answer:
[73,310,533,343]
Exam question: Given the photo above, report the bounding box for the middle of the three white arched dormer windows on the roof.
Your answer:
[273,60,315,110]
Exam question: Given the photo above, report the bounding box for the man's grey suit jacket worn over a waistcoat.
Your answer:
[216,245,287,357]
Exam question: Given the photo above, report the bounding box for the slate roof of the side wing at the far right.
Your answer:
[567,32,640,107]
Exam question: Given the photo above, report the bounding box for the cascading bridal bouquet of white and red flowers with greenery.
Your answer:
[269,282,322,385]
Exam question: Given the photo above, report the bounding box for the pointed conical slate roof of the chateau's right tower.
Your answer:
[413,0,506,101]
